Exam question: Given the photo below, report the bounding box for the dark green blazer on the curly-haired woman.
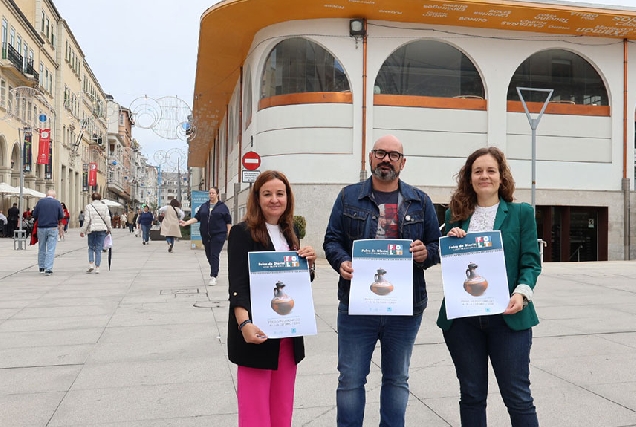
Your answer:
[437,199,541,331]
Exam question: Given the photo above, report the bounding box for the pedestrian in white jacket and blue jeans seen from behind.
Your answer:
[80,192,112,274]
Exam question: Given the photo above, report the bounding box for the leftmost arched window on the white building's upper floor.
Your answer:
[261,37,349,98]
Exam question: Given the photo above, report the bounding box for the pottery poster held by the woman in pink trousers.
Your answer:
[248,251,318,338]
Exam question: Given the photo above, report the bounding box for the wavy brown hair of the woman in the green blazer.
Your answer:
[449,147,515,222]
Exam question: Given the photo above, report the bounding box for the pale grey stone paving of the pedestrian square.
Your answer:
[0,229,636,427]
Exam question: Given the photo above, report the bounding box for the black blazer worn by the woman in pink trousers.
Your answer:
[227,222,305,369]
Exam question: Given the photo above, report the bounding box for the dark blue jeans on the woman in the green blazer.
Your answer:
[444,314,539,427]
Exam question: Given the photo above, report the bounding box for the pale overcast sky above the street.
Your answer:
[53,0,636,163]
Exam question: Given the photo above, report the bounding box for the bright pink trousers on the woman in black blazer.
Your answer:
[237,338,297,427]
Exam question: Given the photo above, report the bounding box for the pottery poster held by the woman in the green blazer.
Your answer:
[439,230,510,319]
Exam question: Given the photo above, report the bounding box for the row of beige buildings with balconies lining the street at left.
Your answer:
[0,0,145,226]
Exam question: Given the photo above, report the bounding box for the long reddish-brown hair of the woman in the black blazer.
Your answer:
[243,170,298,250]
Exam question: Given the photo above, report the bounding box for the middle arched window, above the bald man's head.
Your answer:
[374,40,485,99]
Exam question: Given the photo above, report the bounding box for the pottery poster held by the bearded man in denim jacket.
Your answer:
[349,239,413,316]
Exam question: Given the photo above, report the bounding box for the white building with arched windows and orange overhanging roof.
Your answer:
[188,0,636,261]
